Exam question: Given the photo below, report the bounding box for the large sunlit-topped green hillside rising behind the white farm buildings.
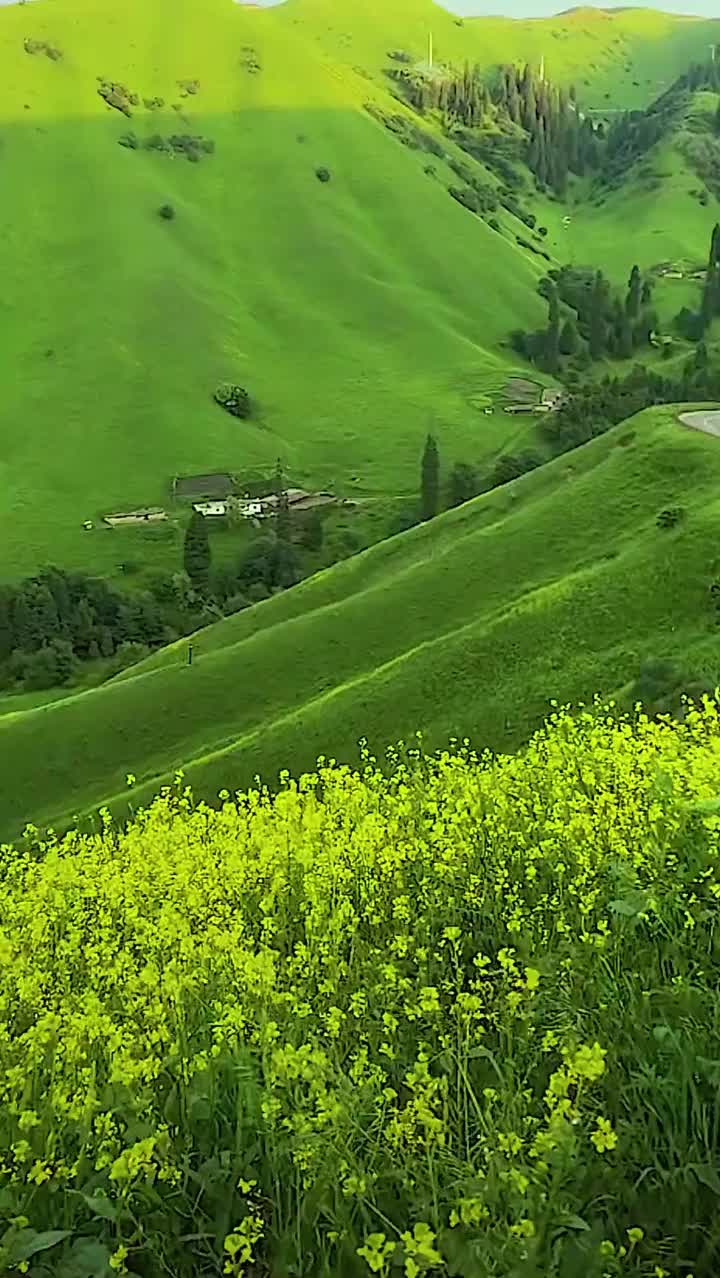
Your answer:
[0,0,549,578]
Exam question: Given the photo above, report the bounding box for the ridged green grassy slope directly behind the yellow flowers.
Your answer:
[0,409,720,835]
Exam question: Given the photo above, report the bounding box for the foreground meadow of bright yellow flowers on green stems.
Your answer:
[0,700,720,1278]
